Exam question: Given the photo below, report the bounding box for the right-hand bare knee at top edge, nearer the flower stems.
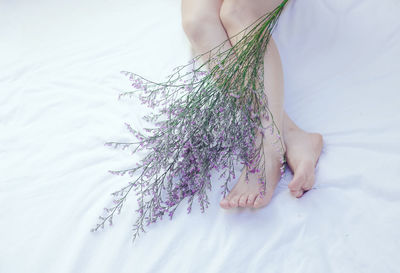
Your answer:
[219,0,253,30]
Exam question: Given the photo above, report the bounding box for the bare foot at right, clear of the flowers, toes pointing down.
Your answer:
[284,113,323,198]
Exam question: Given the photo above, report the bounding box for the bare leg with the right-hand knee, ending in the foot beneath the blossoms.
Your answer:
[220,0,284,208]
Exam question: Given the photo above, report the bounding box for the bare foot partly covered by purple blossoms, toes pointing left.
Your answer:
[220,132,281,209]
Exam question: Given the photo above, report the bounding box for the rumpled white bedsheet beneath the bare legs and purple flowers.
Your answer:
[0,0,400,273]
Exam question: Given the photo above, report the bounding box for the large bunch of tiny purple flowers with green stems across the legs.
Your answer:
[91,0,288,240]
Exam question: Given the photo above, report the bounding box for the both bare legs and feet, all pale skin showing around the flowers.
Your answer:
[182,0,323,209]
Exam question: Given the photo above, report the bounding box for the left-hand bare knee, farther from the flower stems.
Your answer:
[182,12,219,43]
